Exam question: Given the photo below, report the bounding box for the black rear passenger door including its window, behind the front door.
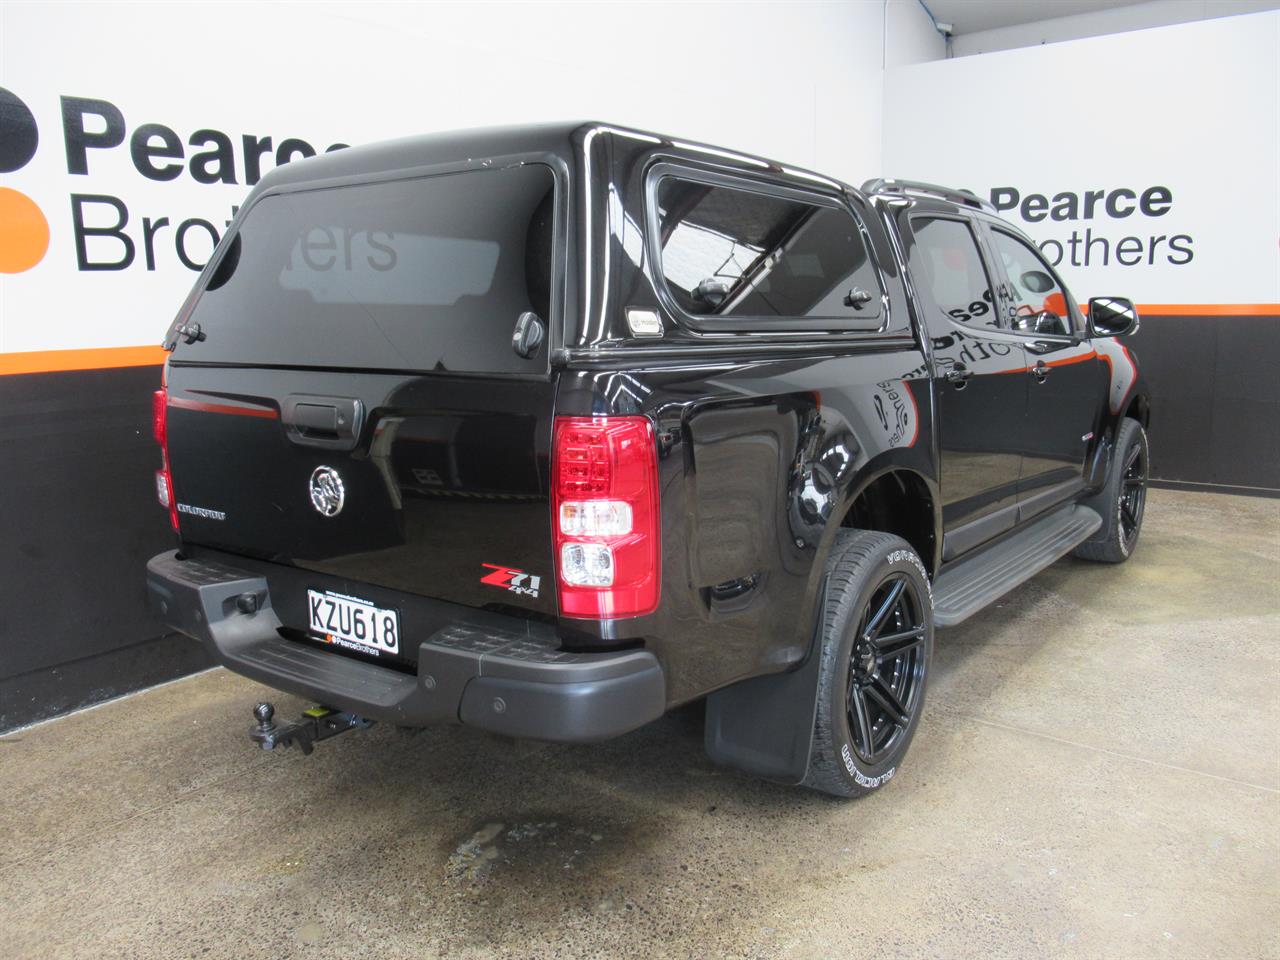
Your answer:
[909,212,1027,561]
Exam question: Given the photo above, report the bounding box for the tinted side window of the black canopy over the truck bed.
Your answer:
[658,177,881,319]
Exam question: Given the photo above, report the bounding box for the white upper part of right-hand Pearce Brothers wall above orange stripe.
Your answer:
[884,13,1280,314]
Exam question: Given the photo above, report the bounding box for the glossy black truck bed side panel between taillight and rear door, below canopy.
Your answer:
[557,344,933,703]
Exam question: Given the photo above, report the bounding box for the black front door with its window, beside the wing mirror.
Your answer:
[988,223,1107,520]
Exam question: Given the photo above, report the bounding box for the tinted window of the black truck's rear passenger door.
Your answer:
[910,218,1000,326]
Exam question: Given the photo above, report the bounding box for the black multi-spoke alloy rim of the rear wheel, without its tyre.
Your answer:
[845,573,925,764]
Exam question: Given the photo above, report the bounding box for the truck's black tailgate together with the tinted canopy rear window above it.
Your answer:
[168,164,563,613]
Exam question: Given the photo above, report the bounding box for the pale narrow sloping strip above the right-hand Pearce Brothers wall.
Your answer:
[951,0,1280,56]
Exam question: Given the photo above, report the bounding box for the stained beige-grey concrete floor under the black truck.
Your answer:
[0,490,1280,960]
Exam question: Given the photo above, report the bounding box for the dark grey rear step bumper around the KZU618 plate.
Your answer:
[147,552,666,742]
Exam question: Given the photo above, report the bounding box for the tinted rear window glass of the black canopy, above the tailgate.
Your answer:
[179,164,554,372]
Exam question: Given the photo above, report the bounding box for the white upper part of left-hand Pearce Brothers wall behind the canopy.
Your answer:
[0,0,942,357]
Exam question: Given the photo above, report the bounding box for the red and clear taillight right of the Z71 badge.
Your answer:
[552,416,660,620]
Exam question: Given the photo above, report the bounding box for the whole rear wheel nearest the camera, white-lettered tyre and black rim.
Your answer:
[804,530,933,796]
